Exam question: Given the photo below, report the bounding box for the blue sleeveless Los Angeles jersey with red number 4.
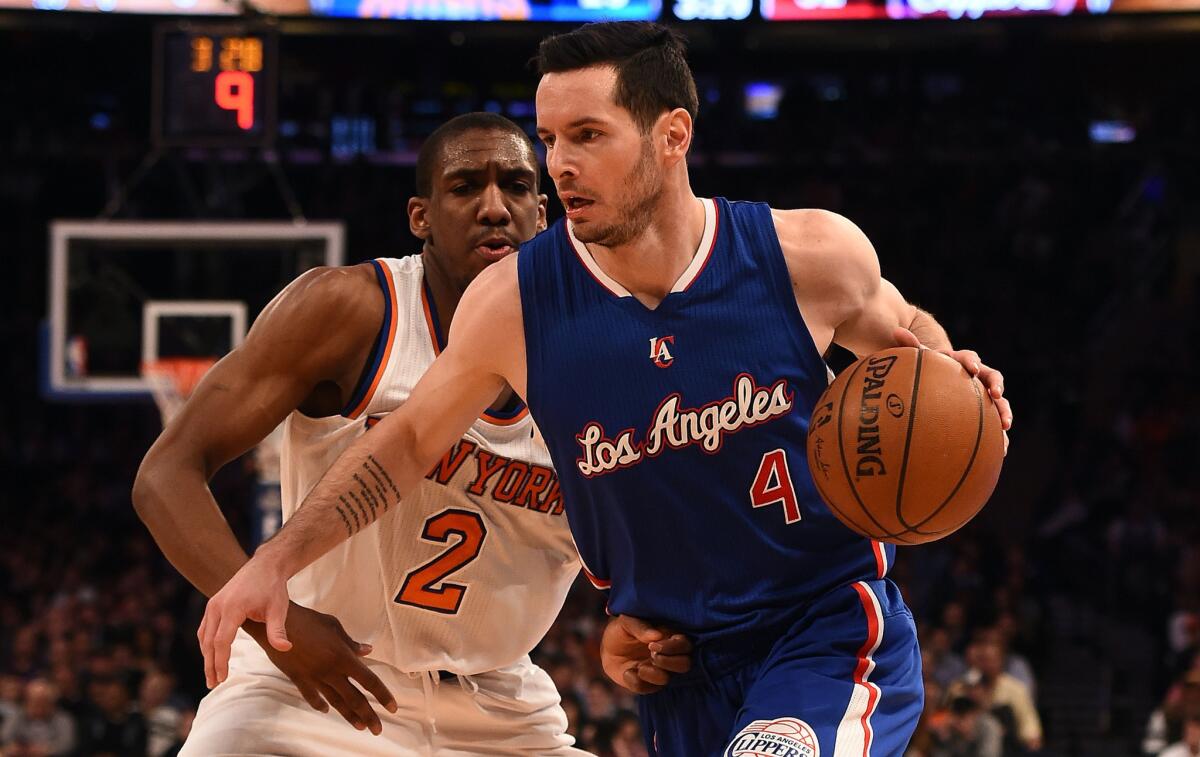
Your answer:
[517,199,894,641]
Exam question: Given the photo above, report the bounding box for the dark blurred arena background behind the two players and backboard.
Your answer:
[0,12,1200,755]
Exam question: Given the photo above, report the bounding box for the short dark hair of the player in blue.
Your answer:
[532,22,700,132]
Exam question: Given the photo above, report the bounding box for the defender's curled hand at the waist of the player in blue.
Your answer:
[600,615,692,693]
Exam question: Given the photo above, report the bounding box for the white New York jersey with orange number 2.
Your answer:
[281,256,580,674]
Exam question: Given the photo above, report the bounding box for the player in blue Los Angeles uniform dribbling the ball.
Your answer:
[202,23,1012,757]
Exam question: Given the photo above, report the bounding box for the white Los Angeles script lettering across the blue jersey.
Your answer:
[575,373,796,479]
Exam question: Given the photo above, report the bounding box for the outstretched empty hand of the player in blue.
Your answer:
[196,557,292,689]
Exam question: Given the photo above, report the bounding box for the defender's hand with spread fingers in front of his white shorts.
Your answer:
[242,602,396,735]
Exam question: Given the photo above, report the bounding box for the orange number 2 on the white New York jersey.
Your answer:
[396,510,487,615]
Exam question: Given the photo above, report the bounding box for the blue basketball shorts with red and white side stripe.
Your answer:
[638,578,924,757]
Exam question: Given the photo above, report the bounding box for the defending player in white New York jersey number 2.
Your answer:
[133,114,688,756]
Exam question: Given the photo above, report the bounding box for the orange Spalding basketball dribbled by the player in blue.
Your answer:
[808,347,1004,545]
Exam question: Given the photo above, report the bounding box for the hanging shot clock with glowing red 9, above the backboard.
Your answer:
[154,25,277,146]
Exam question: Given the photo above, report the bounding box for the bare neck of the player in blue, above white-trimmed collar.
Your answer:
[588,181,704,308]
